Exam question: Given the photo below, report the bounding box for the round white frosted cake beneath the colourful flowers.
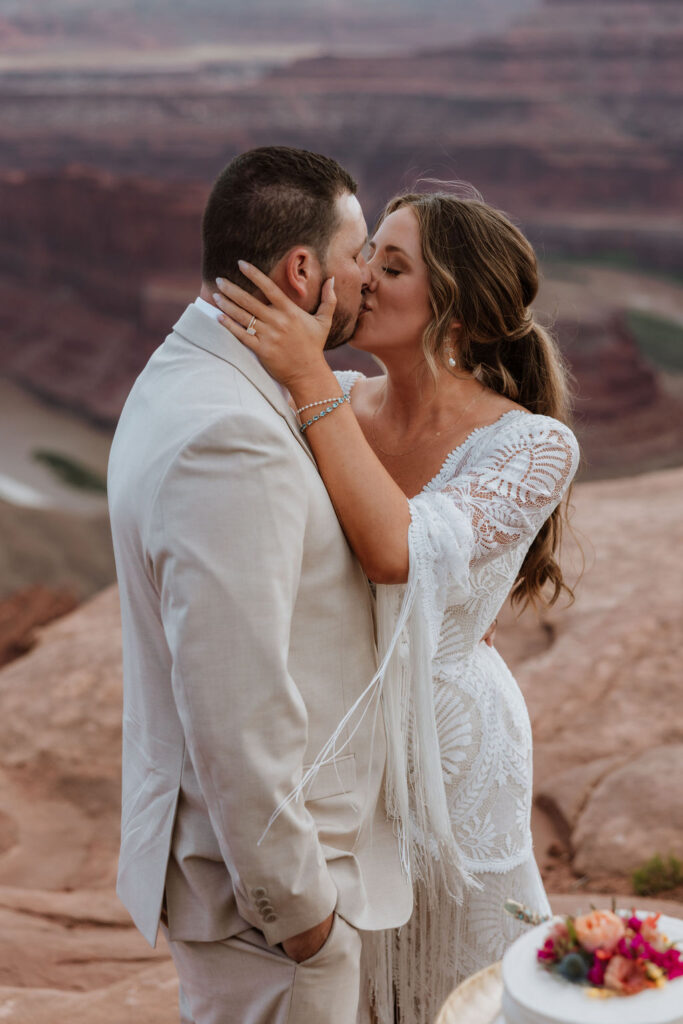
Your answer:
[499,914,683,1024]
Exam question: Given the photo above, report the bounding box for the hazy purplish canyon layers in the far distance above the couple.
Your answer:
[0,0,683,226]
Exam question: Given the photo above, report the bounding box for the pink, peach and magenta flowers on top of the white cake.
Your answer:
[538,910,683,996]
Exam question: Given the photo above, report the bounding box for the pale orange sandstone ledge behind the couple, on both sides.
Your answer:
[0,470,683,1024]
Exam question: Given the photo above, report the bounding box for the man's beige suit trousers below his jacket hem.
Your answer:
[164,914,360,1024]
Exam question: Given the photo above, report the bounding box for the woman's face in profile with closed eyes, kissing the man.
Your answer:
[351,206,432,359]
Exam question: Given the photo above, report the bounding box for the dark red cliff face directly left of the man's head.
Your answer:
[0,166,202,323]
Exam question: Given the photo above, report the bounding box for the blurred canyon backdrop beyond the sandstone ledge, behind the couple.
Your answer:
[0,0,683,599]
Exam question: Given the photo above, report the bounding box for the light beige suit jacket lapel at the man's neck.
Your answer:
[173,305,315,462]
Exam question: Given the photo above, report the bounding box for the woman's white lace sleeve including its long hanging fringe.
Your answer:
[264,411,579,902]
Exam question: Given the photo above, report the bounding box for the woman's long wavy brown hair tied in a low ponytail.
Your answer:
[380,191,573,608]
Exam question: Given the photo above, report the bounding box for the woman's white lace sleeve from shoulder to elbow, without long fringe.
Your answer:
[409,416,579,641]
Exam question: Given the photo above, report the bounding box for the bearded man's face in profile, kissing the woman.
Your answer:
[315,193,370,349]
